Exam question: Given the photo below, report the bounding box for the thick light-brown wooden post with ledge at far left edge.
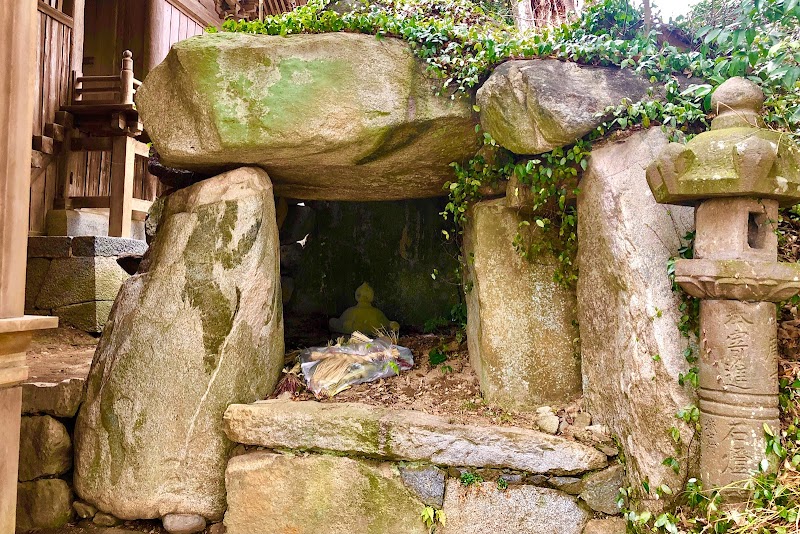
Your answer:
[0,1,58,534]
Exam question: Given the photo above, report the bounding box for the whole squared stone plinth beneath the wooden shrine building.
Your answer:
[25,236,147,333]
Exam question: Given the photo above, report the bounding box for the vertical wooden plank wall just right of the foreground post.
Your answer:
[28,0,73,234]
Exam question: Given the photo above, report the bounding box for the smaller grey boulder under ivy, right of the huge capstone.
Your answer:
[478,59,651,154]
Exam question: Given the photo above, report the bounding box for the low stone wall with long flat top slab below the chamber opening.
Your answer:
[220,401,625,534]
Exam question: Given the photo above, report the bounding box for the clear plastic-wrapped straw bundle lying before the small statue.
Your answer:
[300,332,414,397]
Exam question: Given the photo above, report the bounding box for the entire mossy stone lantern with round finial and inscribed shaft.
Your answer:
[647,78,800,487]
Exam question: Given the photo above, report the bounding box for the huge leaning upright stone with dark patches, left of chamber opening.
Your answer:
[74,168,283,521]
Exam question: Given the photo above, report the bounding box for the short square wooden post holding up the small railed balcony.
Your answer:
[108,135,136,237]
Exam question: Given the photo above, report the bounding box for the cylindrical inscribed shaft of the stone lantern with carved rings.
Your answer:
[699,300,780,487]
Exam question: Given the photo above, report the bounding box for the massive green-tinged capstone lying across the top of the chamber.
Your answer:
[136,33,478,200]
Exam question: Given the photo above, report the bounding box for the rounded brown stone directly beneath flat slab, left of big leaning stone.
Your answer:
[19,415,72,482]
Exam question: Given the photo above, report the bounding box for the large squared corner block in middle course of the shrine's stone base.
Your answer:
[36,257,128,310]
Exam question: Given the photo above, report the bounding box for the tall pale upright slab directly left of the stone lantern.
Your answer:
[577,128,695,507]
